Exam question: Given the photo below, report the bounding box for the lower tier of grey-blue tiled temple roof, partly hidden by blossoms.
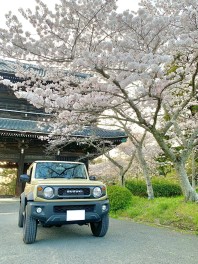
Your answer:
[0,118,127,139]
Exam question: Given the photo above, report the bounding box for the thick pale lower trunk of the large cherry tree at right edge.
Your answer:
[174,160,198,202]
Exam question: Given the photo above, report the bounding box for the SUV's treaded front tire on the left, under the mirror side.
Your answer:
[23,206,37,244]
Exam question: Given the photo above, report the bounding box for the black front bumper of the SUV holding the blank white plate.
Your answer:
[27,200,109,226]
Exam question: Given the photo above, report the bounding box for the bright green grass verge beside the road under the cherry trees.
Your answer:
[110,196,198,235]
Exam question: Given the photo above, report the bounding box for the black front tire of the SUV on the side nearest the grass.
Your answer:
[91,214,109,237]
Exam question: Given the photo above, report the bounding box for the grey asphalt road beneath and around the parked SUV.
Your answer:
[0,199,198,264]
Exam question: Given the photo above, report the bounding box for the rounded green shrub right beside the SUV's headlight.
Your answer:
[108,185,132,211]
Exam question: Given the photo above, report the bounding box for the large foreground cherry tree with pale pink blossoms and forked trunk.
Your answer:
[0,0,198,201]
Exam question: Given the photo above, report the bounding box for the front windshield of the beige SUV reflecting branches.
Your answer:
[35,162,87,179]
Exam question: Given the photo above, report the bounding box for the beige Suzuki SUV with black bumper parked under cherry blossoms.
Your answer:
[18,161,109,244]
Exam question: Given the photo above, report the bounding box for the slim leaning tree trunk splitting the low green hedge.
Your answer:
[137,147,154,200]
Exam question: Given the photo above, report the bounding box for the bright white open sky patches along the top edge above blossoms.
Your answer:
[0,0,140,27]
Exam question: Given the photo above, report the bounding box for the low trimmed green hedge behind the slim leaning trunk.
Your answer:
[126,179,182,197]
